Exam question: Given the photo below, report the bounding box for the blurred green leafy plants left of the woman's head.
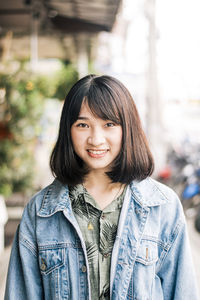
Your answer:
[0,63,78,196]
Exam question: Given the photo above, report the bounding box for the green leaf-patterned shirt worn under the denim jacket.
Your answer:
[69,184,126,300]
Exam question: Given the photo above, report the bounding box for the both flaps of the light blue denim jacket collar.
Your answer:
[37,178,169,217]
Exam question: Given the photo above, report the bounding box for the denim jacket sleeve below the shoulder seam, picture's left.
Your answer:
[4,227,43,300]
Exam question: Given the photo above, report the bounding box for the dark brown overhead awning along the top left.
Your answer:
[0,0,121,34]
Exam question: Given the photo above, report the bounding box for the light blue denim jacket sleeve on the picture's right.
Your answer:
[158,217,199,300]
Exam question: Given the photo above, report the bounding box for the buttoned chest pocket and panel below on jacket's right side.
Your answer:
[127,240,158,300]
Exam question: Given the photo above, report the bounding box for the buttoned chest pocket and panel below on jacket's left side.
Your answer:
[39,246,70,300]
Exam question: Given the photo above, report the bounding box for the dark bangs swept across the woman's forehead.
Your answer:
[84,84,122,124]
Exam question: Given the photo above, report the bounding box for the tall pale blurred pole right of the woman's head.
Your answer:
[145,0,166,171]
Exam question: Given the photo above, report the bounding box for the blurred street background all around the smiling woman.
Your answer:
[0,0,200,299]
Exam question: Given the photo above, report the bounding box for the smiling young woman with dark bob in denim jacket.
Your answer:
[5,75,198,300]
